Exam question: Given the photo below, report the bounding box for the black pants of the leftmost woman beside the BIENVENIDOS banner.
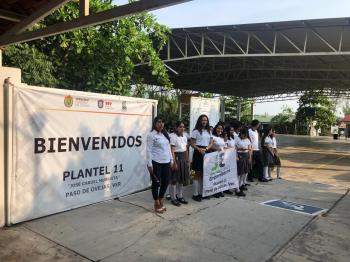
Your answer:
[151,161,170,200]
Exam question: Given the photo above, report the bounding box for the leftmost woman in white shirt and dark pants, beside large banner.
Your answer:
[147,116,173,213]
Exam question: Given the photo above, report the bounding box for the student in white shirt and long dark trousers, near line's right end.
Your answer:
[248,119,268,182]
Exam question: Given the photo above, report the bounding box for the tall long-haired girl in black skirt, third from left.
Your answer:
[190,115,213,202]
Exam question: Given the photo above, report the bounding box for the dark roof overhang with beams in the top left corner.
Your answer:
[0,0,191,47]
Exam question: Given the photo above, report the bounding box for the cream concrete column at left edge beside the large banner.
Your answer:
[0,64,21,227]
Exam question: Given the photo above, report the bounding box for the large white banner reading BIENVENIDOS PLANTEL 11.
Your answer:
[11,87,156,223]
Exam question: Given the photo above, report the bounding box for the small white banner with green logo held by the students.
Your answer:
[203,148,239,196]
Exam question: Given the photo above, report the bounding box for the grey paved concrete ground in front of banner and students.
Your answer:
[0,136,350,262]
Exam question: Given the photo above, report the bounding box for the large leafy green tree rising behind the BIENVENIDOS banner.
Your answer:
[4,0,171,95]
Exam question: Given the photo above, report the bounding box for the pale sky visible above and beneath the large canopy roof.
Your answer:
[113,0,350,115]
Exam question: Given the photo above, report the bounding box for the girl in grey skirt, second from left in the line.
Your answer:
[169,121,189,206]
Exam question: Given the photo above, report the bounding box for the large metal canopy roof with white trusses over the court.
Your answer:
[144,18,350,98]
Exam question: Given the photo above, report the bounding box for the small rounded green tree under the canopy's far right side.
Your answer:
[296,91,336,134]
